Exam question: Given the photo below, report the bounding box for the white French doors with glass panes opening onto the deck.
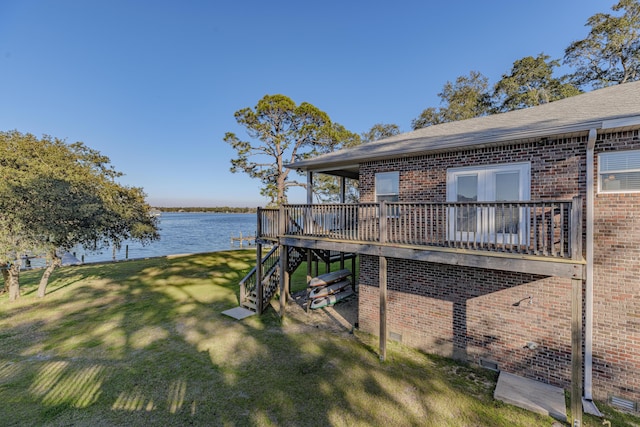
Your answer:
[447,163,531,244]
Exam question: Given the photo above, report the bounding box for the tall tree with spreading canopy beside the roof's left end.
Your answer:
[223,95,359,205]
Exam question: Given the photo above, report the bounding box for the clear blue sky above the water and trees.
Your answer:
[0,0,616,206]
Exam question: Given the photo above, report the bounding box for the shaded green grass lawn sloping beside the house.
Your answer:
[0,250,640,426]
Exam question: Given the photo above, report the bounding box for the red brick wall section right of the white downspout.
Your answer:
[593,131,640,401]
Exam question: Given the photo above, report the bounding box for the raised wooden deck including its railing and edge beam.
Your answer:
[256,201,585,279]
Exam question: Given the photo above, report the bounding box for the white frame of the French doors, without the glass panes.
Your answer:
[447,162,531,245]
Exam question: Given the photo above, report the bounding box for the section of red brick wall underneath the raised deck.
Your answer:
[359,257,571,386]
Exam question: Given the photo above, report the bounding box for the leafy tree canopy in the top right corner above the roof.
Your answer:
[564,0,640,88]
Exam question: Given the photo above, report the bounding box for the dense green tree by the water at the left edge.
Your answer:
[0,131,159,299]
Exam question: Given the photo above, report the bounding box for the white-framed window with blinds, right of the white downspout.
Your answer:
[598,150,640,193]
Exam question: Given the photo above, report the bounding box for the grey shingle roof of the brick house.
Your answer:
[287,81,640,175]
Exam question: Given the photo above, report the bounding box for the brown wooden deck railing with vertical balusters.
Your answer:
[258,197,582,259]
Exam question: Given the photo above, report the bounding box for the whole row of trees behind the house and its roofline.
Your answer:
[223,0,640,206]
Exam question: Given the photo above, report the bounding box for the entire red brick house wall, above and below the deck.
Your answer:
[359,131,640,400]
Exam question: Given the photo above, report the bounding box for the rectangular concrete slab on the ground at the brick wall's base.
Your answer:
[493,372,567,422]
